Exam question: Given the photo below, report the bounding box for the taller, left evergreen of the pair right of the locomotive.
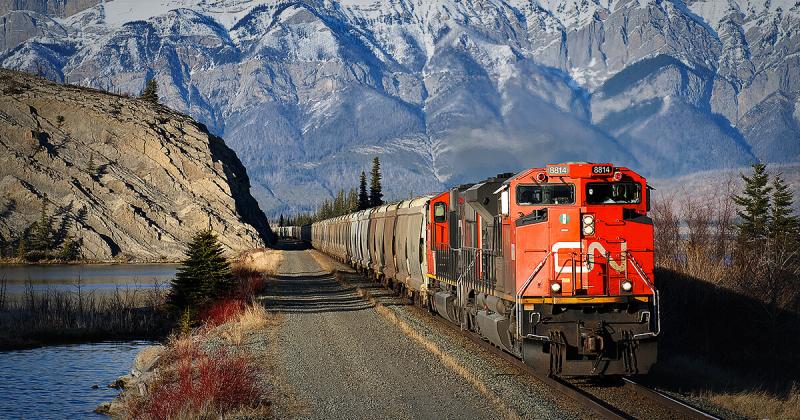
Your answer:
[733,163,772,245]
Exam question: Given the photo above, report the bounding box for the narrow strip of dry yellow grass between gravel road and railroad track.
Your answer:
[334,270,520,419]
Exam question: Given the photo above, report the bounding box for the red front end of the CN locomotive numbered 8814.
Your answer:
[500,163,659,376]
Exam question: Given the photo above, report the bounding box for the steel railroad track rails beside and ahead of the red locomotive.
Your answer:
[420,308,718,420]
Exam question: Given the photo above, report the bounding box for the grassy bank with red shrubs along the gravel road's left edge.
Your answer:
[111,250,282,419]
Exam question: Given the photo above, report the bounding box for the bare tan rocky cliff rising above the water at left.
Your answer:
[0,70,271,260]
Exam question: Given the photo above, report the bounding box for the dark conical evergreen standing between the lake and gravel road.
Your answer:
[169,229,235,308]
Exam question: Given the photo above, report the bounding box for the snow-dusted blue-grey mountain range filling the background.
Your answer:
[0,0,800,214]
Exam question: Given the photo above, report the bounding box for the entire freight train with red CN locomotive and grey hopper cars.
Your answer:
[278,162,661,376]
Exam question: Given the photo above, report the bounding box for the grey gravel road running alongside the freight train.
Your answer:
[264,251,499,419]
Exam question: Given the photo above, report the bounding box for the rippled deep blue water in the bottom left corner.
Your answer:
[0,341,151,419]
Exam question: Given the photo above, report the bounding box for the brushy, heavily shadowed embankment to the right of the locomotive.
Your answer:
[650,190,800,419]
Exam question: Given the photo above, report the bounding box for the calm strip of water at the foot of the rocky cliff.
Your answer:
[0,264,178,299]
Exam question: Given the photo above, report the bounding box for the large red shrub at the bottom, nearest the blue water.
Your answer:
[131,346,261,419]
